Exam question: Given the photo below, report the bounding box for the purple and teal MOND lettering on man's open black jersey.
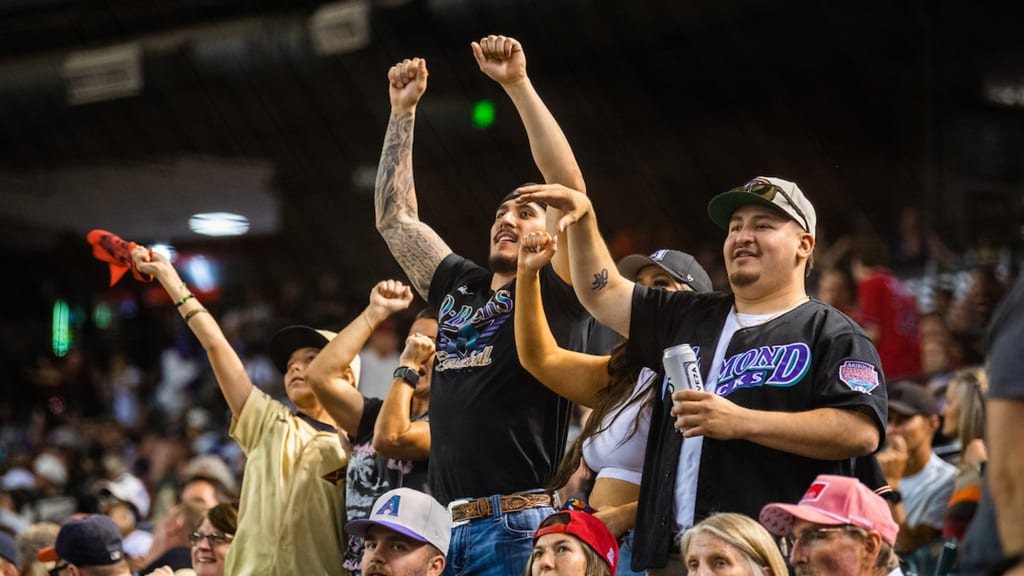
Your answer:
[715,342,811,397]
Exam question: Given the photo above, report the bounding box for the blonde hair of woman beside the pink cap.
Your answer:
[679,512,790,576]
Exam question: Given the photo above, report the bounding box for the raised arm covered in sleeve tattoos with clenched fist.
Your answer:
[374,58,452,299]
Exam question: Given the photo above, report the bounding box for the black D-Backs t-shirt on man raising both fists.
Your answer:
[428,254,589,504]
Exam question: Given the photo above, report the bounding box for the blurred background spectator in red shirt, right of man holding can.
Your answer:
[851,236,921,381]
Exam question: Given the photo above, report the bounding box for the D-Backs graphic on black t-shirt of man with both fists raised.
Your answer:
[434,290,513,372]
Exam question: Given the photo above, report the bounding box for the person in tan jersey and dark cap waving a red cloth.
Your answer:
[132,246,350,576]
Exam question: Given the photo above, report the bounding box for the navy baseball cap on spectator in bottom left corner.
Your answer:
[37,515,125,566]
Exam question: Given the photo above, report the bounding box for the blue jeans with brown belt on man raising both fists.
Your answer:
[443,500,555,576]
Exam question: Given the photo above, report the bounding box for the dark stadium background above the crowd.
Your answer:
[0,0,1024,362]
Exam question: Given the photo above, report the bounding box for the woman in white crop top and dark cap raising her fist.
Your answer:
[515,233,711,576]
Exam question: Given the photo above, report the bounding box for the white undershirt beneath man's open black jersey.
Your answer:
[673,314,777,533]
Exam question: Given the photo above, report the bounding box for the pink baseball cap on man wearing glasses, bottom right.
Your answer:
[760,475,899,545]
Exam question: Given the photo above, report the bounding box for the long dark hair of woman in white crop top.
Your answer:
[548,339,654,491]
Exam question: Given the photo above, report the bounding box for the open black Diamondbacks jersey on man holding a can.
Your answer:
[629,286,888,569]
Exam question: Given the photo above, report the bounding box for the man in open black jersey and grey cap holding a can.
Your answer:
[518,177,887,575]
